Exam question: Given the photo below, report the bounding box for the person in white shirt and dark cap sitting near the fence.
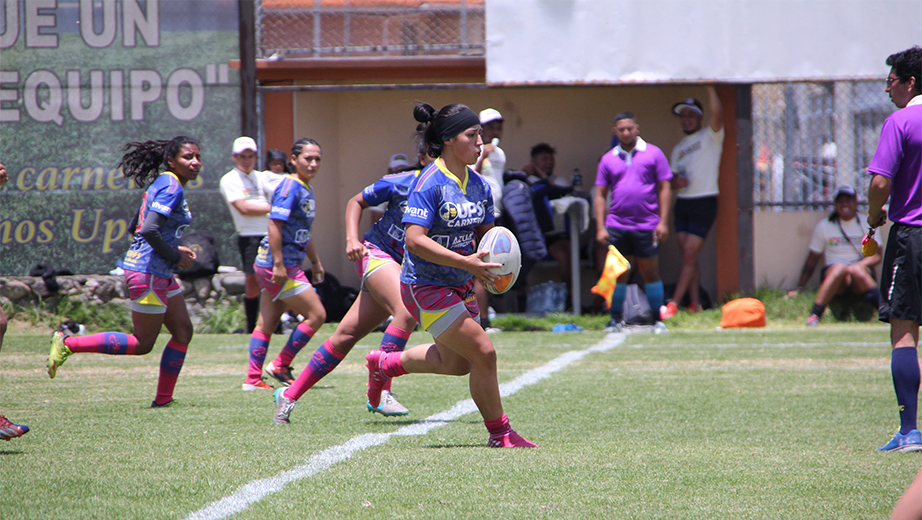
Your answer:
[788,185,881,326]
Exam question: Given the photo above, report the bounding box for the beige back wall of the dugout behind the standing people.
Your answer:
[293,86,716,296]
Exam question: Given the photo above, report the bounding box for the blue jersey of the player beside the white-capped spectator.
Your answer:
[255,175,315,269]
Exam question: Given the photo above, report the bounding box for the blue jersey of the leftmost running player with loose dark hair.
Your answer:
[118,172,192,278]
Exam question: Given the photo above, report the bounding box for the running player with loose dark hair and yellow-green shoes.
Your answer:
[48,136,202,408]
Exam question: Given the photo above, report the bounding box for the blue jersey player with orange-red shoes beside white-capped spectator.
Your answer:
[243,139,326,390]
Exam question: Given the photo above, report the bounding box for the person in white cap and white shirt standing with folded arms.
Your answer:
[221,137,274,333]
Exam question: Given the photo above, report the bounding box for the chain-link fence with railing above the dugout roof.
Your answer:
[256,0,485,58]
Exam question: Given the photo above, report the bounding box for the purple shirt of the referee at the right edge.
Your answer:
[868,100,922,226]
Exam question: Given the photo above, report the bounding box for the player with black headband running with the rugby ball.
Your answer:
[365,103,536,447]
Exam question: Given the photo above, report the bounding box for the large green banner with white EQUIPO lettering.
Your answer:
[0,0,241,276]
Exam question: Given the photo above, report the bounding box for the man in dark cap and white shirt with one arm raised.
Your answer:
[662,85,724,319]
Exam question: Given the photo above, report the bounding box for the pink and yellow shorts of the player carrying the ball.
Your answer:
[400,278,480,338]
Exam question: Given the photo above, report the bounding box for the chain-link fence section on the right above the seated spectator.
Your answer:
[752,81,895,210]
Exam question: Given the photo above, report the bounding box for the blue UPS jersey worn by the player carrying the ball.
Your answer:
[400,159,495,287]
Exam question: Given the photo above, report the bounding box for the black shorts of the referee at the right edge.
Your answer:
[878,223,922,323]
